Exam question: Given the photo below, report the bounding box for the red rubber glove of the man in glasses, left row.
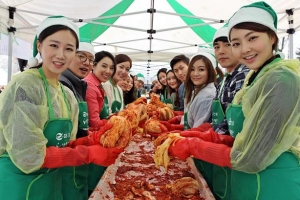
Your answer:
[68,124,113,148]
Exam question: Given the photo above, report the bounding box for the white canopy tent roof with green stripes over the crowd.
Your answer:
[0,0,300,83]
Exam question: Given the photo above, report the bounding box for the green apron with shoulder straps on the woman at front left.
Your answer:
[0,68,72,200]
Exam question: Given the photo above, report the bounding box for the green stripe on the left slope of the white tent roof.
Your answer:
[79,0,134,41]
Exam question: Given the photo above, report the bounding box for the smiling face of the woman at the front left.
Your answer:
[37,30,76,80]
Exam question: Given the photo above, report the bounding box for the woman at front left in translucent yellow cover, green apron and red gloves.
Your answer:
[0,16,123,200]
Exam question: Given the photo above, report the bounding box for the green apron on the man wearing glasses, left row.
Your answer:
[61,98,89,200]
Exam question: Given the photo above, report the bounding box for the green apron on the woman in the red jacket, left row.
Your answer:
[88,86,109,190]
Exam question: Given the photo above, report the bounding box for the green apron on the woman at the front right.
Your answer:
[226,77,300,200]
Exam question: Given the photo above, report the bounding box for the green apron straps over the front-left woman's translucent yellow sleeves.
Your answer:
[38,67,71,119]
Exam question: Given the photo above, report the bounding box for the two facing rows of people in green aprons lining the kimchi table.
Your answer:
[0,2,300,200]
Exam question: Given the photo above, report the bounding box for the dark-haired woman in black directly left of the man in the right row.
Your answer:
[167,70,181,111]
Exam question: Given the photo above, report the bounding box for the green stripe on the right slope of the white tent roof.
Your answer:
[168,0,216,46]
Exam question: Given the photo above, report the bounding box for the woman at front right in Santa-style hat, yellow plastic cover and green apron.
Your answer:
[169,2,300,200]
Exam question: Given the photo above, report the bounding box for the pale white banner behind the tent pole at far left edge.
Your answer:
[0,33,32,60]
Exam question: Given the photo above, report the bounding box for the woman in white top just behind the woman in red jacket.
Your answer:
[102,54,132,114]
